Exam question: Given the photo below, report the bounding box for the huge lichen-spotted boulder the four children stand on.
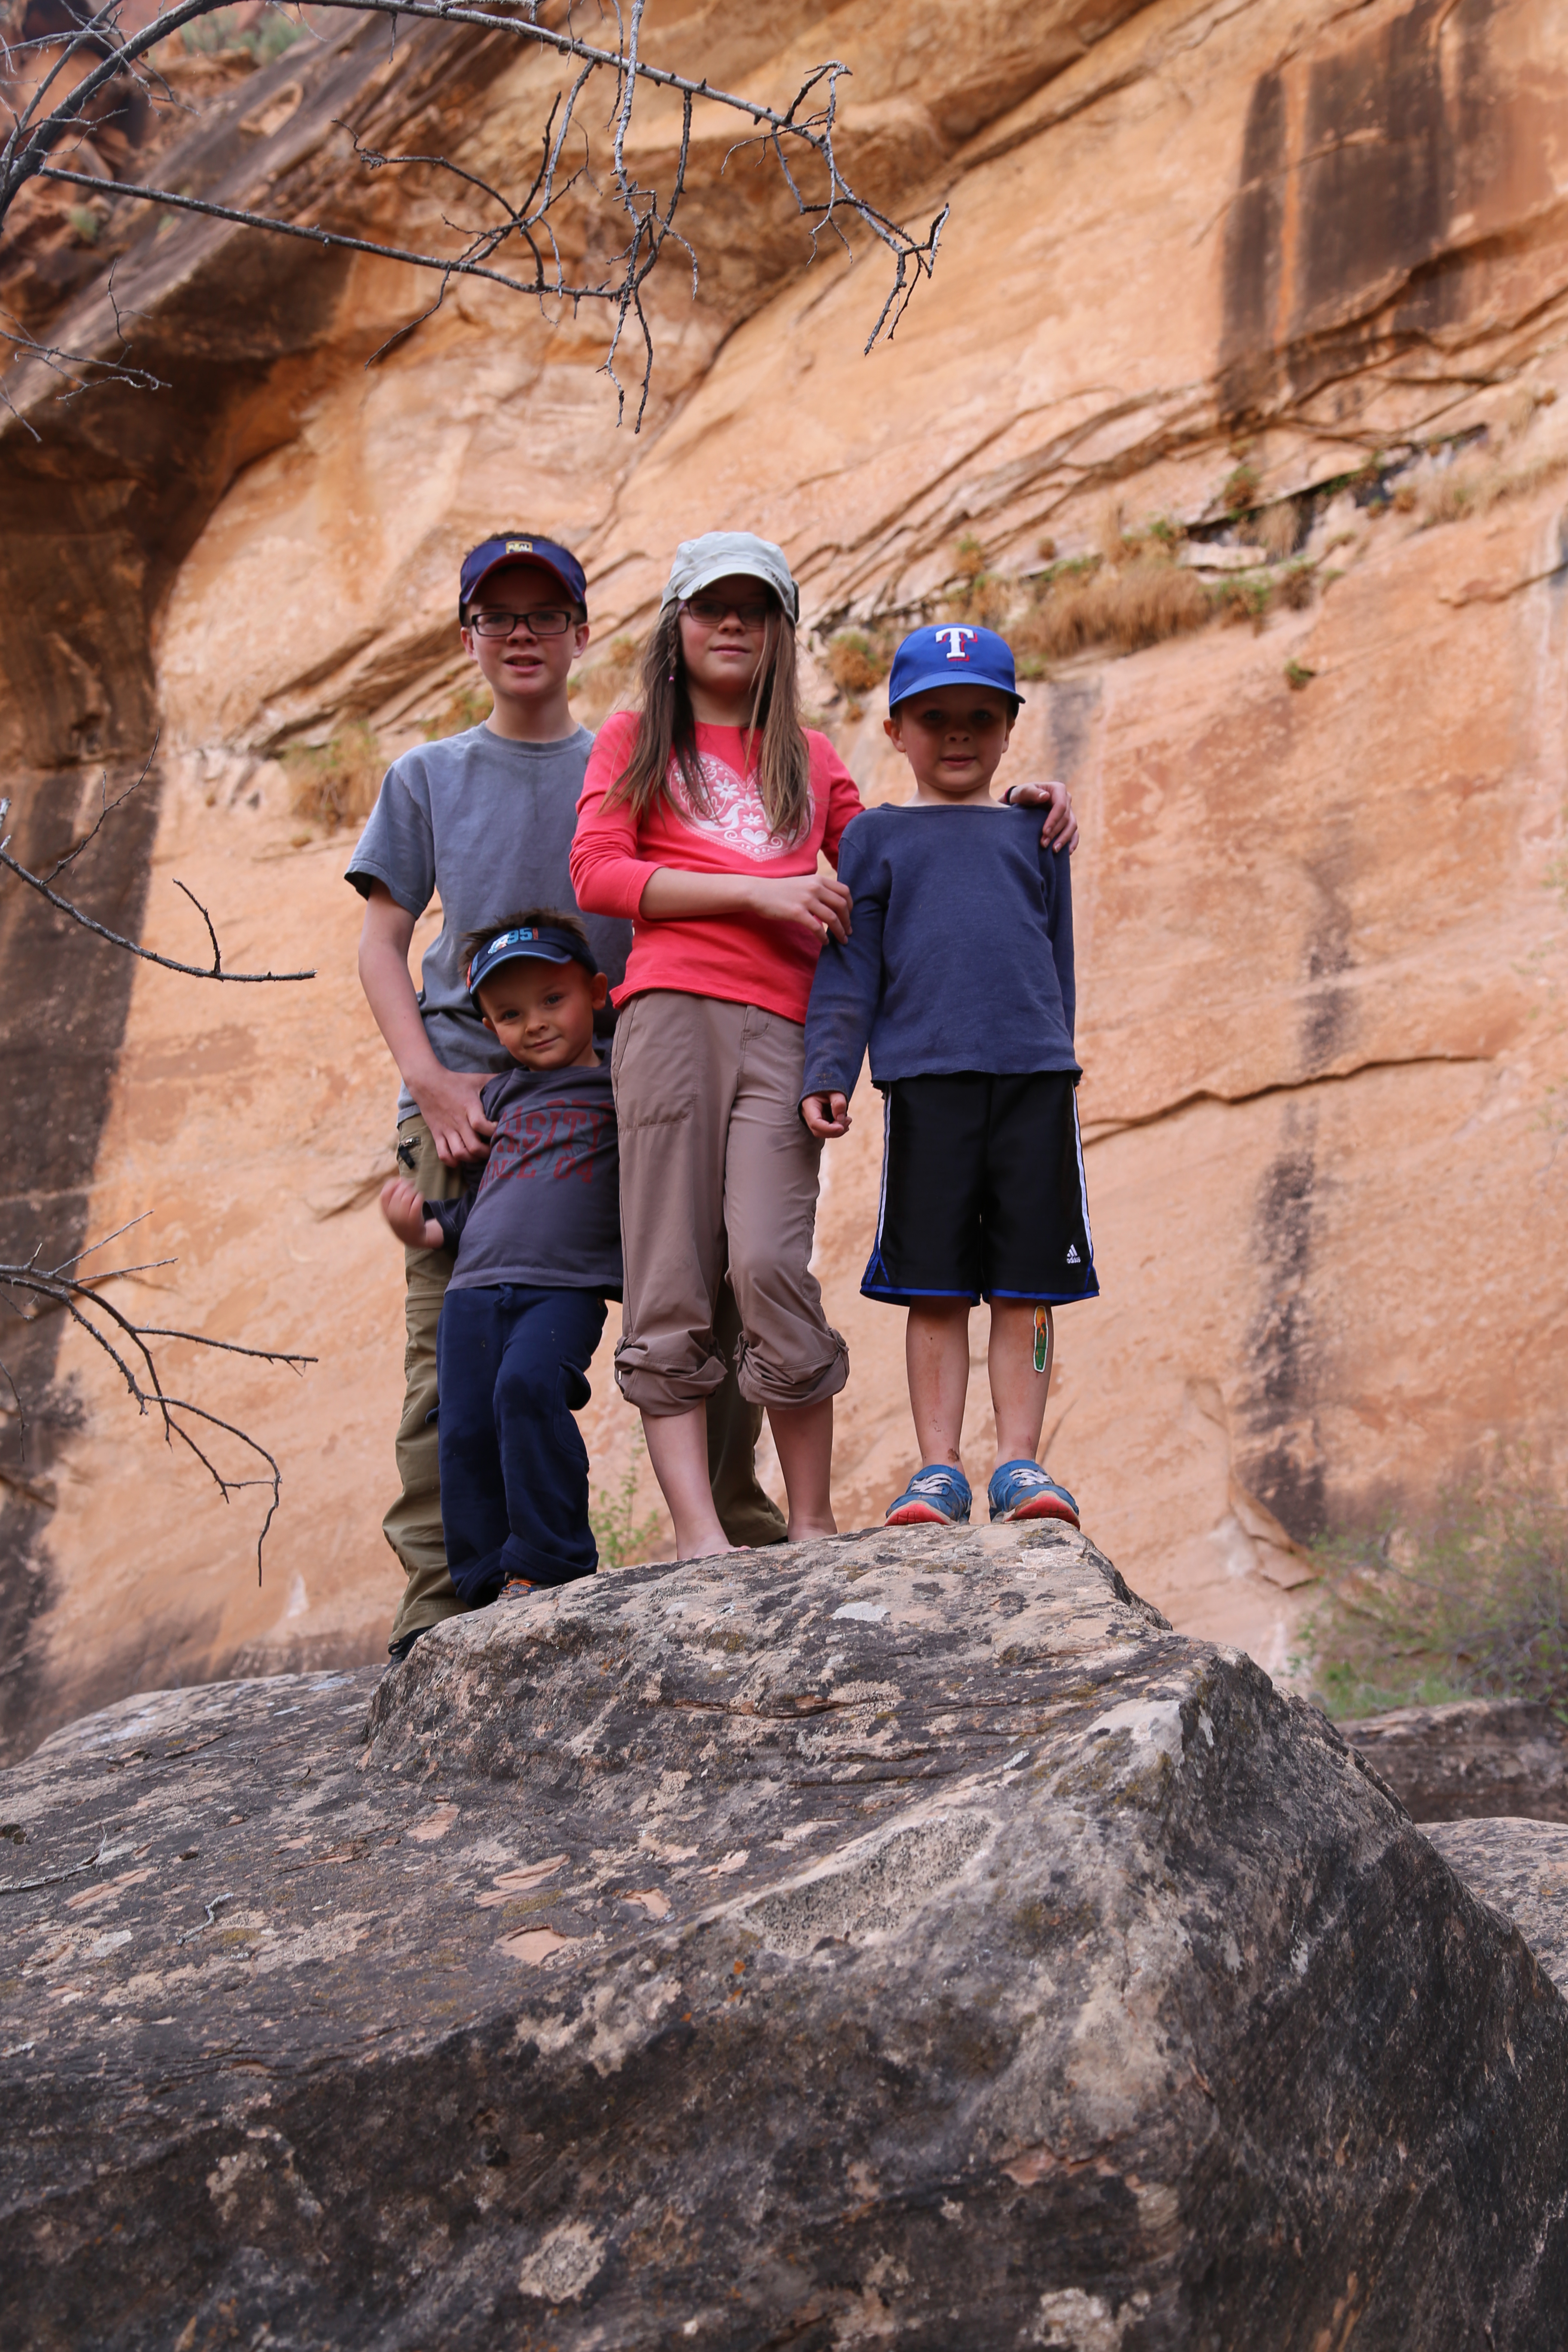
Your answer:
[2,1529,1568,2352]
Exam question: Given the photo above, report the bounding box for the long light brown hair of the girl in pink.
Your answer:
[606,597,811,842]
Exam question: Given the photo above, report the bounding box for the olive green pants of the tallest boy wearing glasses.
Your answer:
[381,1117,785,1642]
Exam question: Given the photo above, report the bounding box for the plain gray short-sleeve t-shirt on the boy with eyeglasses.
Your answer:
[346,727,632,1120]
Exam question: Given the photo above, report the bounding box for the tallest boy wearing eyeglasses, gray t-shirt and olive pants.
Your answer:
[348,532,783,1658]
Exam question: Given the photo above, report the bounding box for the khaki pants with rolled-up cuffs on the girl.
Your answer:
[611,988,848,1416]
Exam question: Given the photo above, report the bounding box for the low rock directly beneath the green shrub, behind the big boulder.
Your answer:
[1340,1698,1568,1820]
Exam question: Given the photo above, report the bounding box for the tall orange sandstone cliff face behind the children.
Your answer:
[0,0,1568,1752]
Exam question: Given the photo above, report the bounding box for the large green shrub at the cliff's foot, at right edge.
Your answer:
[1295,1482,1568,1722]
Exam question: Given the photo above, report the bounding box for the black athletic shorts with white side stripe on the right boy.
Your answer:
[861,1070,1100,1305]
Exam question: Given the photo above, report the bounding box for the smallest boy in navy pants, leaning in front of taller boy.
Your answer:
[381,908,621,1609]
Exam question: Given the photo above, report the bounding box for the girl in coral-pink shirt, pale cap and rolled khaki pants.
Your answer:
[571,532,861,1559]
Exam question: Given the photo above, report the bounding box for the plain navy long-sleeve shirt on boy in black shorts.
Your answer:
[802,802,1079,1093]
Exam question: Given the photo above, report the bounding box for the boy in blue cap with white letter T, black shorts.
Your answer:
[802,623,1100,1526]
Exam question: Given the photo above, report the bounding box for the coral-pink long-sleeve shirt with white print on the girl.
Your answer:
[571,710,861,1021]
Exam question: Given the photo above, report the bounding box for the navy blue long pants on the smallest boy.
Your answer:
[435,1284,604,1606]
